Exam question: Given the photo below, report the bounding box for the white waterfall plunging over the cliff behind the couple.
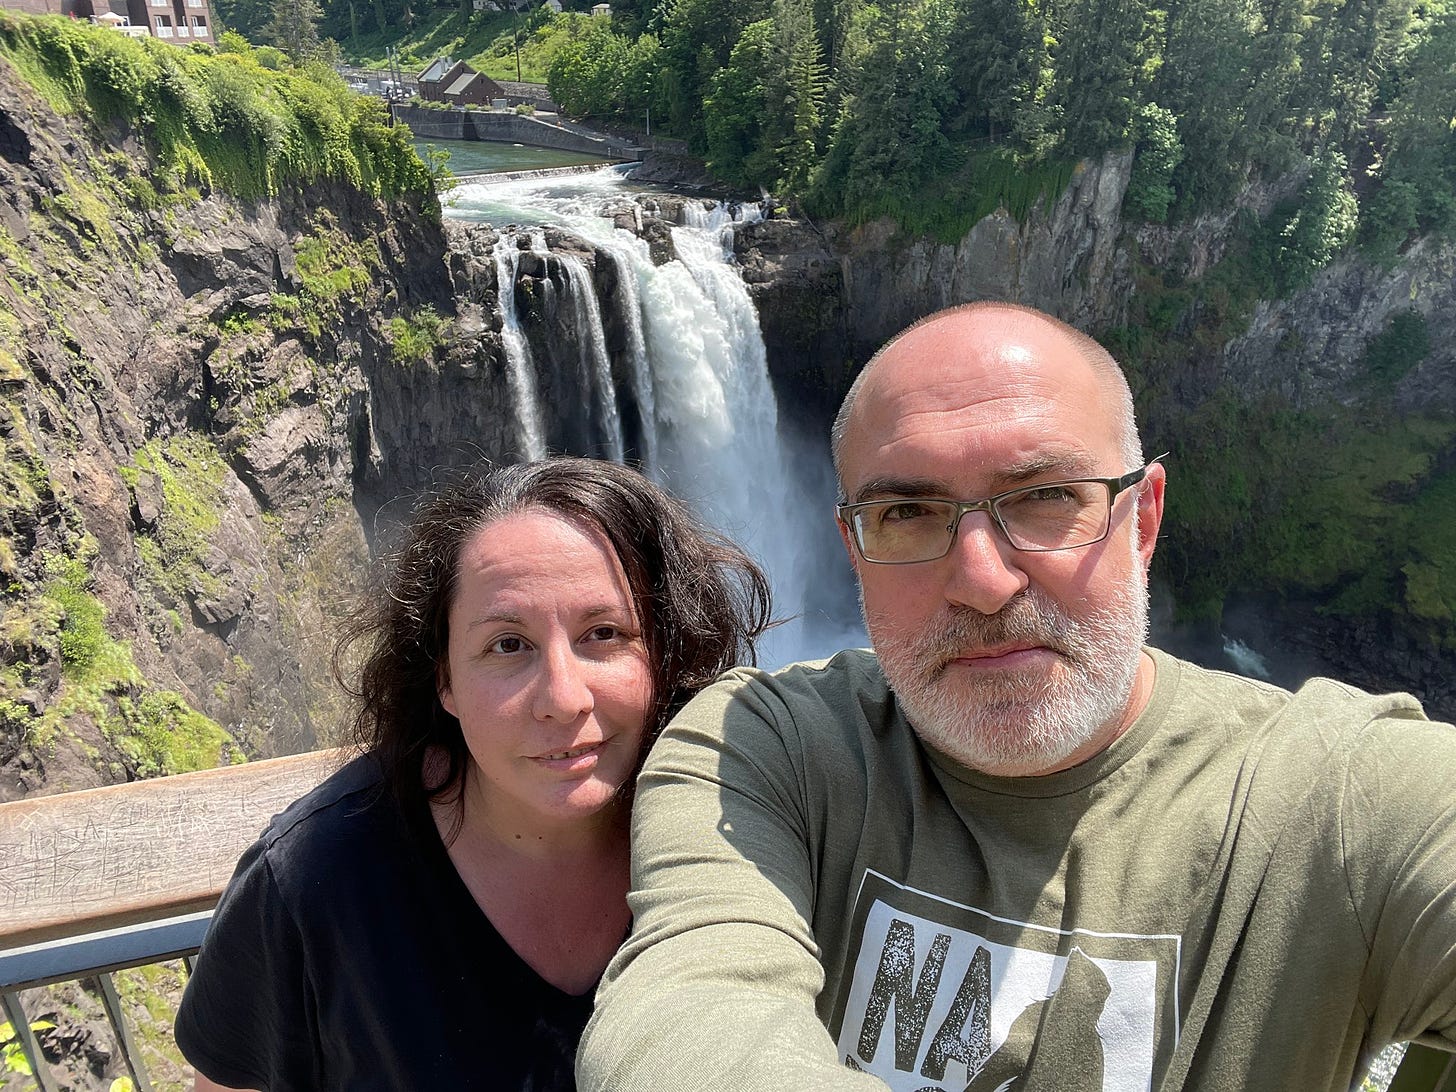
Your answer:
[446,169,865,665]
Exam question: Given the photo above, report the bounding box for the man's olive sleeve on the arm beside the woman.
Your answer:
[577,678,884,1092]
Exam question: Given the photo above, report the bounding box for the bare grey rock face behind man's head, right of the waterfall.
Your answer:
[737,154,1456,428]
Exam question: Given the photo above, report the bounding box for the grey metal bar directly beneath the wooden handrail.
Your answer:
[0,910,213,990]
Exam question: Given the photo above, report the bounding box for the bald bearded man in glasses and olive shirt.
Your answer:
[578,304,1456,1092]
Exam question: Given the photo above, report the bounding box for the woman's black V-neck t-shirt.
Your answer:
[176,756,591,1092]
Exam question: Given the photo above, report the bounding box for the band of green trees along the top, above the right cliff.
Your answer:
[524,0,1456,241]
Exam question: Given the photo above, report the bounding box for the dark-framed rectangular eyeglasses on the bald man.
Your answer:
[836,453,1168,565]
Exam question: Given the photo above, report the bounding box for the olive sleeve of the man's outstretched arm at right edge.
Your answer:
[1340,718,1456,1050]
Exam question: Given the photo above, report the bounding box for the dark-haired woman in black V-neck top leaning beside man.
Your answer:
[176,459,769,1092]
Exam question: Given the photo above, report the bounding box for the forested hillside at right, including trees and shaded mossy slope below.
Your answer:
[532,0,1456,675]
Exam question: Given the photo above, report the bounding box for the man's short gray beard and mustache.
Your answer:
[865,565,1147,776]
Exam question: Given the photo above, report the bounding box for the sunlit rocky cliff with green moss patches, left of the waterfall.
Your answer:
[0,61,535,799]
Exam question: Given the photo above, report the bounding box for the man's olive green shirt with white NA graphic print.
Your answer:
[578,649,1456,1092]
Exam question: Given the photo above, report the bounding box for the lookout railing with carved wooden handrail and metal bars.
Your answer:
[0,751,1456,1092]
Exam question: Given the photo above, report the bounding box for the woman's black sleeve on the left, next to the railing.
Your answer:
[176,842,319,1092]
